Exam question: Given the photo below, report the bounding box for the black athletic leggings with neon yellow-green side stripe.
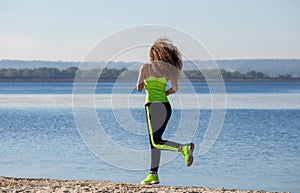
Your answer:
[145,102,181,172]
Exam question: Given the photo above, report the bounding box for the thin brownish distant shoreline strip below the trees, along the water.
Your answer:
[0,78,300,83]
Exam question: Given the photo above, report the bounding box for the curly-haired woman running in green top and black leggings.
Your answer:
[137,38,194,184]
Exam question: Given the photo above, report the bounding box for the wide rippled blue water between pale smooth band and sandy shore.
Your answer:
[0,109,300,192]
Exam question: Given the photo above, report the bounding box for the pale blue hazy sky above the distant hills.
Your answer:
[0,0,300,61]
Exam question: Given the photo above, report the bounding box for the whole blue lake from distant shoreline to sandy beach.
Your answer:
[0,82,300,193]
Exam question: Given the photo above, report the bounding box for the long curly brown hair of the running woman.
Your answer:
[150,38,182,79]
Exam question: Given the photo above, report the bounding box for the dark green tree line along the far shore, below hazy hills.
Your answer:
[0,67,292,81]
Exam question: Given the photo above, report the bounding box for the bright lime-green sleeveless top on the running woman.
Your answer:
[144,65,169,104]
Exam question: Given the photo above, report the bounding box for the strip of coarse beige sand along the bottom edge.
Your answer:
[0,177,290,193]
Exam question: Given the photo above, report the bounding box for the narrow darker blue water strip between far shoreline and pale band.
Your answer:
[0,82,300,94]
